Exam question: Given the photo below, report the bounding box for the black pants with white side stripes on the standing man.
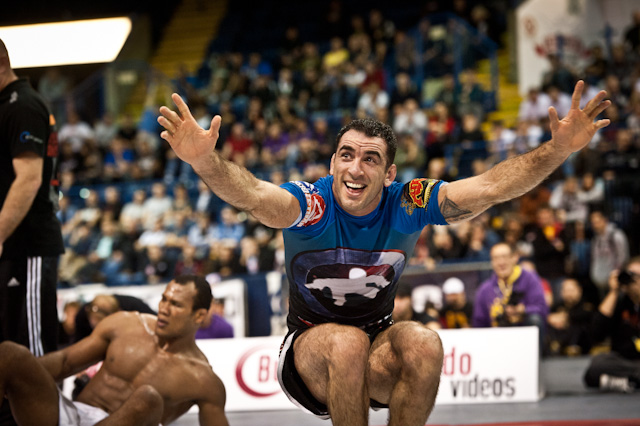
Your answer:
[0,256,58,426]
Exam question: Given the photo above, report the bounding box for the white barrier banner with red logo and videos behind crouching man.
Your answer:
[198,327,540,411]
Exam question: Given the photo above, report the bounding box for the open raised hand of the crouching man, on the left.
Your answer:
[158,93,222,165]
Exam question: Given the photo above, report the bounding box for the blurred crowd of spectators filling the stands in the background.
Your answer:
[41,1,640,362]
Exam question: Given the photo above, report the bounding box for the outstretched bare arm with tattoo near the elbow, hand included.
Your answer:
[438,81,611,223]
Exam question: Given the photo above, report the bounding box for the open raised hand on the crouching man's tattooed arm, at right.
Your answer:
[549,80,611,152]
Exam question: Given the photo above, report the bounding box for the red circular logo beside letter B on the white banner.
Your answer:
[236,345,280,398]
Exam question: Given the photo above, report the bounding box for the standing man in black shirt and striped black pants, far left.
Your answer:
[0,40,64,356]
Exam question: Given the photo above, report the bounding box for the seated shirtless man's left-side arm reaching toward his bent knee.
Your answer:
[38,312,121,381]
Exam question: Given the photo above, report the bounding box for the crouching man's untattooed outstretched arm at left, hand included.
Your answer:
[158,93,300,228]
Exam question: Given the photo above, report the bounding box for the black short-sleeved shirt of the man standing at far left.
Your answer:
[0,79,64,259]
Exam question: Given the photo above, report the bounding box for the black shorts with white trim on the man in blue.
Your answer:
[278,318,393,419]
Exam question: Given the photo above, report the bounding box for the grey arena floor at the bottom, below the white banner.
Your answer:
[172,354,640,426]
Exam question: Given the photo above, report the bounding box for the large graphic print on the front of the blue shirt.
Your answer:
[291,248,405,319]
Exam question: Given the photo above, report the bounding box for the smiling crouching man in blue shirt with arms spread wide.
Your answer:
[158,81,610,426]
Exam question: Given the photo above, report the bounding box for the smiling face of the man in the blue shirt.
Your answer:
[330,130,396,216]
